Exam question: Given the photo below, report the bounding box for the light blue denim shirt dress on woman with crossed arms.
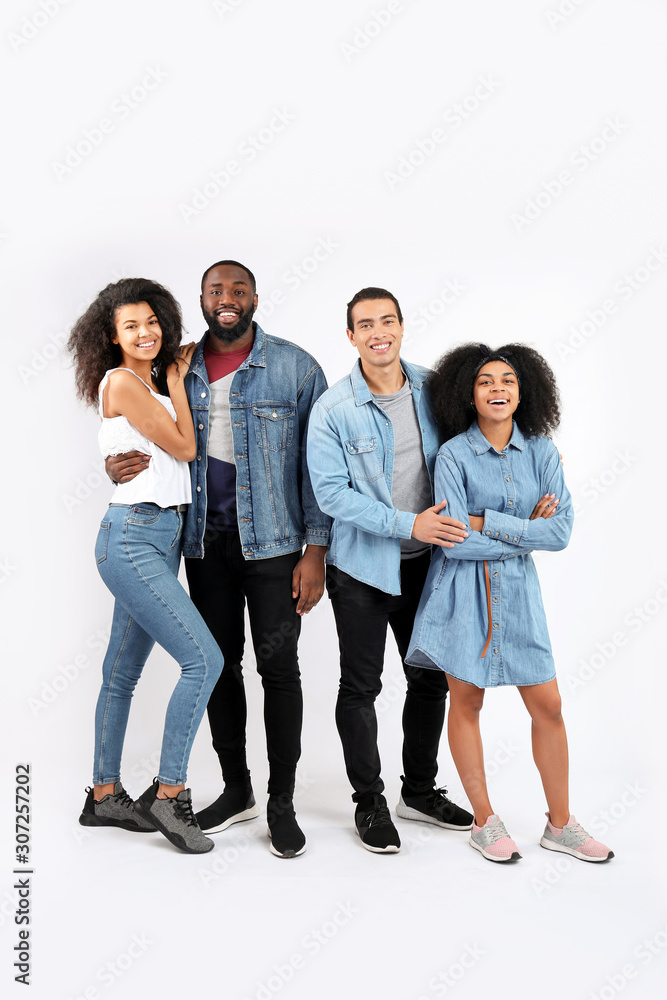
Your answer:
[406,422,573,687]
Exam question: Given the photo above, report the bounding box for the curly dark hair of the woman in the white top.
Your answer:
[67,278,183,406]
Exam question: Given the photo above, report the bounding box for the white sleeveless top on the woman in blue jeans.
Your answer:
[98,368,192,507]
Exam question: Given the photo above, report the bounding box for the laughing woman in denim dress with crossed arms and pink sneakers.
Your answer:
[406,344,613,862]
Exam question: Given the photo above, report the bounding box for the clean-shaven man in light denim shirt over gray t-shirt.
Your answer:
[308,288,472,853]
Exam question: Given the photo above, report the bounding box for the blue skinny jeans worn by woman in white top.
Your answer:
[93,503,223,785]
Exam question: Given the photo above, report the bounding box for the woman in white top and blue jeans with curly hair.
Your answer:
[68,278,222,854]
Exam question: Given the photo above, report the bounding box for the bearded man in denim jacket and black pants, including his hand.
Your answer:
[107,260,330,858]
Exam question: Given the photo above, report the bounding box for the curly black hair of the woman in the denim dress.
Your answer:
[427,344,560,441]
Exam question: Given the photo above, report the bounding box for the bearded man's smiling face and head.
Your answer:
[199,264,257,346]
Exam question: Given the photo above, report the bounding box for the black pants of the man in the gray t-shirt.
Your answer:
[327,554,447,802]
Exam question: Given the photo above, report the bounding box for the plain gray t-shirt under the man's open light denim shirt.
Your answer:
[373,378,433,559]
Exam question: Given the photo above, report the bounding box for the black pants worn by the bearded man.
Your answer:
[185,531,303,795]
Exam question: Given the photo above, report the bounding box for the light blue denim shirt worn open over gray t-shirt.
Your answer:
[308,361,438,594]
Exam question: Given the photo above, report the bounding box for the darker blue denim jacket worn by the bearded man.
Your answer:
[183,326,331,559]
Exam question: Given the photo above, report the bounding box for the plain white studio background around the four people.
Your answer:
[0,0,667,1000]
